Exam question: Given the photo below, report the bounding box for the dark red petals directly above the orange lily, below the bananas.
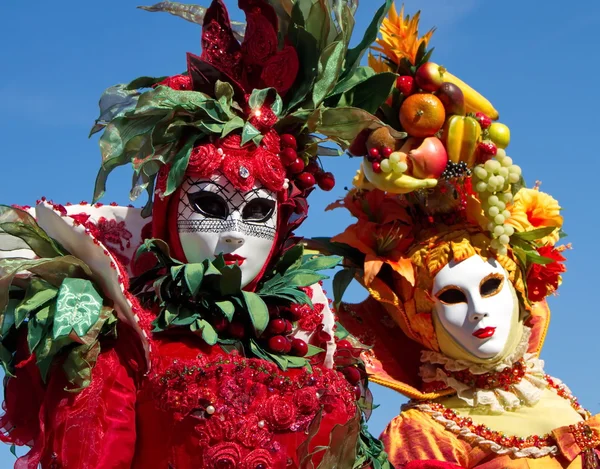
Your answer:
[325,189,412,225]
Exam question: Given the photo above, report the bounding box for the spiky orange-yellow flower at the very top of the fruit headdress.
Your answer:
[369,4,435,67]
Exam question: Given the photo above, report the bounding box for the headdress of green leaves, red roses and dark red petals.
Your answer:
[92,0,396,215]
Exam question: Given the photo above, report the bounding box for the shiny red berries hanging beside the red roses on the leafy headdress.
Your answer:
[280,134,335,191]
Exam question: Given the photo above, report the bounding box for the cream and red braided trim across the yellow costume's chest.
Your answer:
[411,404,558,458]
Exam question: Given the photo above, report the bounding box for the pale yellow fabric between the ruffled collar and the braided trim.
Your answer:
[437,389,583,437]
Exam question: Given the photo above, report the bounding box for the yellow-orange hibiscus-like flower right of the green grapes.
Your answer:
[507,188,563,246]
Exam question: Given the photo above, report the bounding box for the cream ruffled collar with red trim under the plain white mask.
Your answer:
[419,328,548,413]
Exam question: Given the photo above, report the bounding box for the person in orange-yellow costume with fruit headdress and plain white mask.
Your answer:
[318,4,600,469]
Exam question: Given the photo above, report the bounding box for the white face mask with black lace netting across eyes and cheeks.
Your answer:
[177,173,277,287]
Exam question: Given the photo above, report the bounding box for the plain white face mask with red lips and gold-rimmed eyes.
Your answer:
[432,255,518,359]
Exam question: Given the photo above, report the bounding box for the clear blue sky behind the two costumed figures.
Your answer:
[0,0,600,469]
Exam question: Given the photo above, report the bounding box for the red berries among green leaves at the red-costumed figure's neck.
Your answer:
[265,304,308,357]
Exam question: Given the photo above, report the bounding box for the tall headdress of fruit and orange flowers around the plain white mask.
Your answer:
[317,8,567,397]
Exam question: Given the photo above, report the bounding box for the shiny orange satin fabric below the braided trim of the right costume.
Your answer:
[380,409,582,469]
